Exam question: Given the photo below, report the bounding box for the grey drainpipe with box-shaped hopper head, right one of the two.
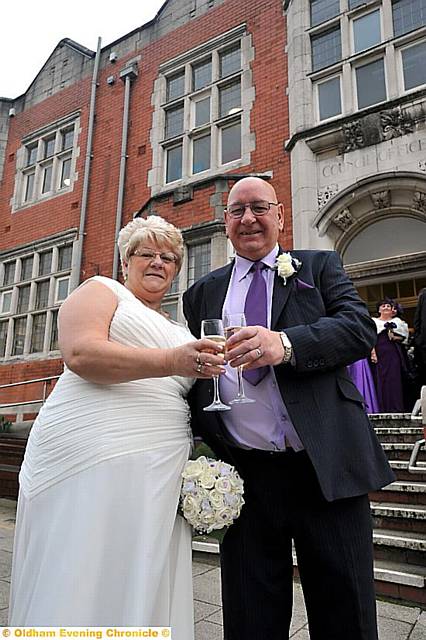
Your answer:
[112,62,138,280]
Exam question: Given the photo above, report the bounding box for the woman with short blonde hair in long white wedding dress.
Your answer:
[9,216,223,640]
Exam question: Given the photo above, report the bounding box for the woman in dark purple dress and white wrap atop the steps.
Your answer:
[372,299,407,413]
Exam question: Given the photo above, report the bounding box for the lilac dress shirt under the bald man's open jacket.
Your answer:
[220,246,303,451]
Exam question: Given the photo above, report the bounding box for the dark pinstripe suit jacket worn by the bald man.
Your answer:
[183,251,395,500]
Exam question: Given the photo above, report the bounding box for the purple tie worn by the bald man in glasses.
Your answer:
[243,260,269,386]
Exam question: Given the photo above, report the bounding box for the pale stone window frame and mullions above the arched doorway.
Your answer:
[306,0,426,123]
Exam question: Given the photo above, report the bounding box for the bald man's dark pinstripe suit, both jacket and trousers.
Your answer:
[184,251,394,640]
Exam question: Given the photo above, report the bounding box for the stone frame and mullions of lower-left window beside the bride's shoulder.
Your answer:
[0,229,76,364]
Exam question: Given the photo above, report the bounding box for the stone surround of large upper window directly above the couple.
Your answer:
[148,24,255,195]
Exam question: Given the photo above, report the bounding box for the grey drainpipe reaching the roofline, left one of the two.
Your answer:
[71,38,101,291]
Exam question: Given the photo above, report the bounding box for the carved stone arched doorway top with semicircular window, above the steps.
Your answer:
[315,172,426,327]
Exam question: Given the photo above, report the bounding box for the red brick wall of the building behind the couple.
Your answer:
[0,0,292,392]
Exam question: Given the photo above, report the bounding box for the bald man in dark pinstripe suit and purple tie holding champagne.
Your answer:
[184,177,394,640]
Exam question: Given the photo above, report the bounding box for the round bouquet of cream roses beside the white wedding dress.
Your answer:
[180,456,244,534]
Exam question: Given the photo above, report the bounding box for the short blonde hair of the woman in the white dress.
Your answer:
[117,216,183,275]
